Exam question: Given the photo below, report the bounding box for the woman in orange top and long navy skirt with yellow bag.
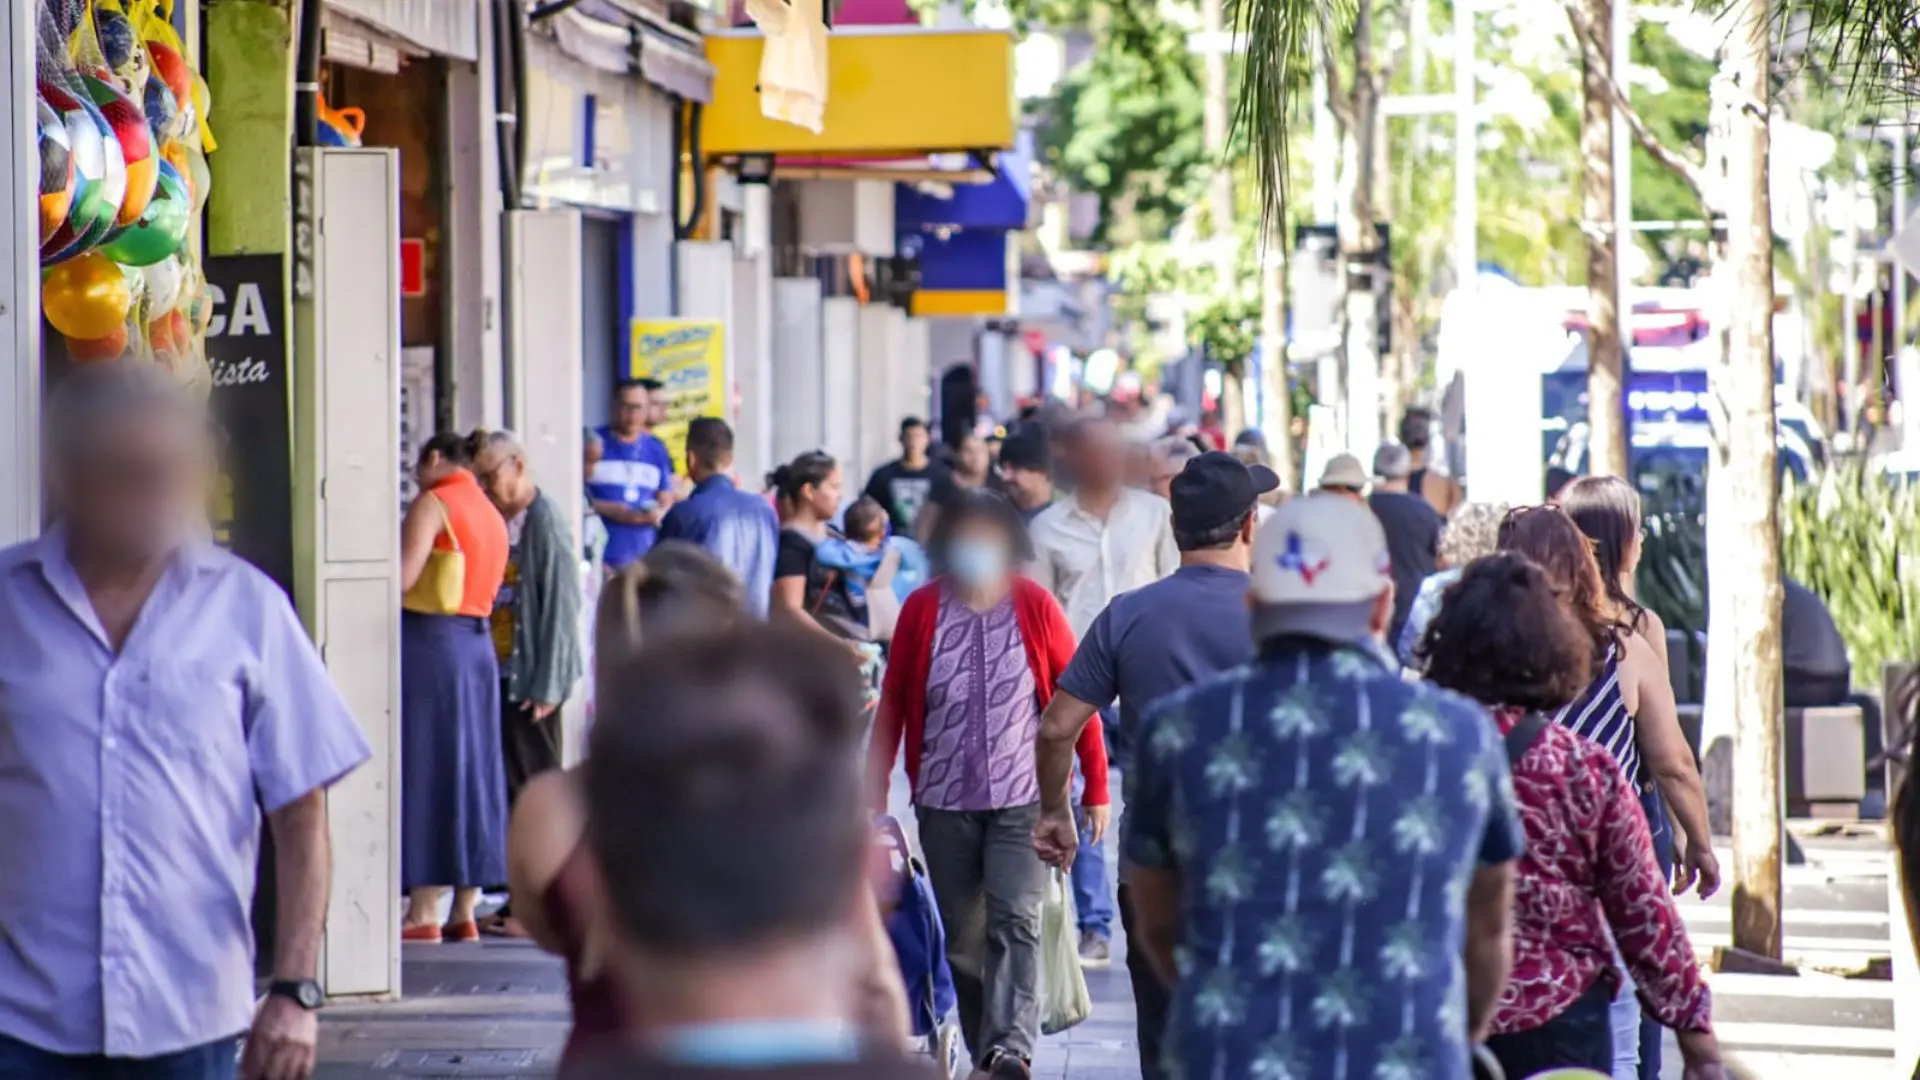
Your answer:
[399,432,509,942]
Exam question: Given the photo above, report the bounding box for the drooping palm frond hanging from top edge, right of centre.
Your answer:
[1227,0,1336,223]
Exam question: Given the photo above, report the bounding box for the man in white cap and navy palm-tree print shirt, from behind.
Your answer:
[1121,494,1523,1080]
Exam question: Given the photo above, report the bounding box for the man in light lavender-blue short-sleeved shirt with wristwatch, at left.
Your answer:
[0,363,371,1080]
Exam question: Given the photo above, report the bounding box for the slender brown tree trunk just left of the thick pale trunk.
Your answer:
[1574,0,1628,477]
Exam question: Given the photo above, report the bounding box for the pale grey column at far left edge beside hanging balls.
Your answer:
[0,0,40,546]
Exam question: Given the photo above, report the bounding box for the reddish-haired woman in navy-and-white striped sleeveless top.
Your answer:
[1500,505,1720,1080]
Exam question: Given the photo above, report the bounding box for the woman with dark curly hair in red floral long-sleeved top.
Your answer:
[1423,552,1724,1080]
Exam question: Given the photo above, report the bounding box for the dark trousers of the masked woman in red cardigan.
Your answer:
[916,803,1046,1065]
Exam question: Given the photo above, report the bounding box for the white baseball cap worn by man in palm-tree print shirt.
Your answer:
[1254,492,1394,642]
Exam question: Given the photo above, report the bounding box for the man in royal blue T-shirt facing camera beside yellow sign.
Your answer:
[588,379,674,571]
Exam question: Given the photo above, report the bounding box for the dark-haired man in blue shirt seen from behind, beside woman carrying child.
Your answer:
[660,417,780,619]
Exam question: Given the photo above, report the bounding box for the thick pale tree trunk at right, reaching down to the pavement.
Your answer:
[1705,0,1784,959]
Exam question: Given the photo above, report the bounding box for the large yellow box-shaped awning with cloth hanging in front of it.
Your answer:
[701,27,1018,158]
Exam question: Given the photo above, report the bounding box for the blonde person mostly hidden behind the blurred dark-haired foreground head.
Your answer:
[507,540,908,1059]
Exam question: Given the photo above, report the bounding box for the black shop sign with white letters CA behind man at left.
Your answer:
[205,256,294,596]
